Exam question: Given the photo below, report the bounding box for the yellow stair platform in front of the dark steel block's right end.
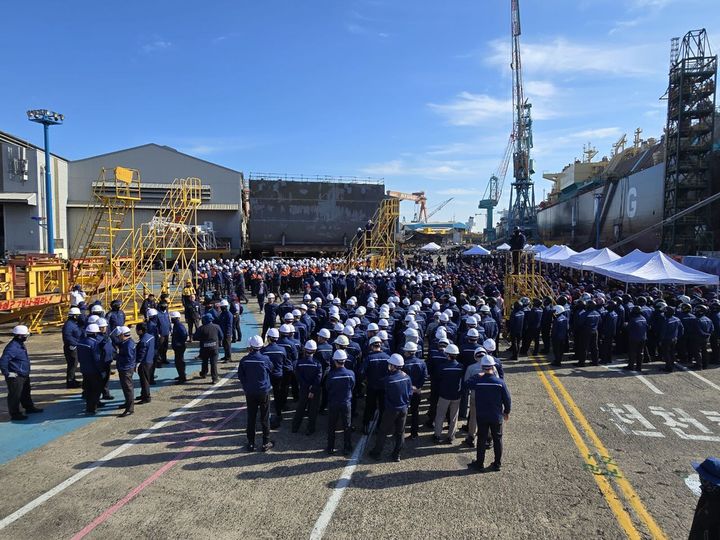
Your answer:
[345,197,400,271]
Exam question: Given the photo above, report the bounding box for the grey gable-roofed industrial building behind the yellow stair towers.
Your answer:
[67,143,245,254]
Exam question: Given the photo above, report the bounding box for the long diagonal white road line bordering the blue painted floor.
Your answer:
[0,371,237,530]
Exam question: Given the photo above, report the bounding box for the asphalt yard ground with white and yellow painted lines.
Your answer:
[0,310,720,539]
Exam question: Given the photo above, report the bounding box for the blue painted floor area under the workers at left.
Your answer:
[0,322,255,465]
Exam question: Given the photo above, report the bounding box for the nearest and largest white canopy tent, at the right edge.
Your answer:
[596,250,720,285]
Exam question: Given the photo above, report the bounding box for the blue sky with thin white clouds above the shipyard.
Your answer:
[0,0,720,221]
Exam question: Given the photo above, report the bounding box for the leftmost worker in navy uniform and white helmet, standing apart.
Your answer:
[0,325,42,420]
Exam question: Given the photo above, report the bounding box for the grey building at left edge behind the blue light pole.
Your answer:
[0,131,68,257]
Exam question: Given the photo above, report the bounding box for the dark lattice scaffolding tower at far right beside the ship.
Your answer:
[662,29,717,254]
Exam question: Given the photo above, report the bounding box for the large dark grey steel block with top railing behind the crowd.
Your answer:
[248,174,385,253]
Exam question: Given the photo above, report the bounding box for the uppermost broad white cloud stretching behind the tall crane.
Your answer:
[487,37,664,76]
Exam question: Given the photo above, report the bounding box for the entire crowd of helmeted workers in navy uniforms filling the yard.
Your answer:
[0,249,720,476]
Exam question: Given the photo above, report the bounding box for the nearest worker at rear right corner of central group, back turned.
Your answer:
[466,356,511,471]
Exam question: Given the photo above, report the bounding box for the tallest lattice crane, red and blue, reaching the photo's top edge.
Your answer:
[508,0,537,238]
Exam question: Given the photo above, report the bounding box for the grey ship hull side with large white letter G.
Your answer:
[537,163,665,254]
